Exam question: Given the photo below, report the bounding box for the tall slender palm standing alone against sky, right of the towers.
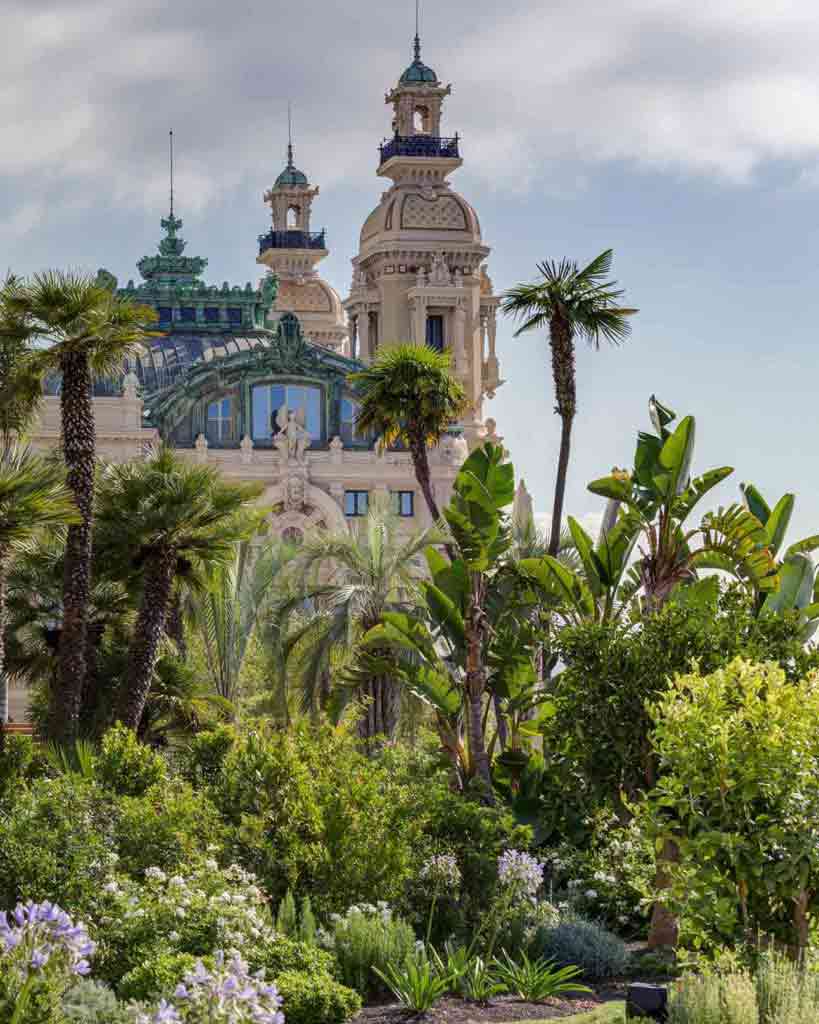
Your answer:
[501,249,638,558]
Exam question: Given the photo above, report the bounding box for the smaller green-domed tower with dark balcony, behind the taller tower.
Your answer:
[256,136,347,353]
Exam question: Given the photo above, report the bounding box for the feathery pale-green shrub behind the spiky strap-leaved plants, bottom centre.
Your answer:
[322,903,416,996]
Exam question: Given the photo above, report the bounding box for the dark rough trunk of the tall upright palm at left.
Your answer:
[47,352,96,742]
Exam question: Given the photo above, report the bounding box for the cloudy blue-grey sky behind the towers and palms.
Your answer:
[0,0,819,539]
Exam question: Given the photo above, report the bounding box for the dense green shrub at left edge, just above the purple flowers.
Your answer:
[0,776,116,916]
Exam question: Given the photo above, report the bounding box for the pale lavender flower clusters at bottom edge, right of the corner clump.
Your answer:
[137,951,285,1024]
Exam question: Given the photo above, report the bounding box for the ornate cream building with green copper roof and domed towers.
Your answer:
[30,28,501,540]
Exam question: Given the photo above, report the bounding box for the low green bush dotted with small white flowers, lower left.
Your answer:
[90,858,274,985]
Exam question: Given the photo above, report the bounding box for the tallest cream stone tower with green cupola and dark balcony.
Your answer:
[344,28,503,446]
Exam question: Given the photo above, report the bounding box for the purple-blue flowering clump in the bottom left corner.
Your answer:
[0,900,95,1024]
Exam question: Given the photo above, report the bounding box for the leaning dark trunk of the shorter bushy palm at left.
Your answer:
[117,551,176,731]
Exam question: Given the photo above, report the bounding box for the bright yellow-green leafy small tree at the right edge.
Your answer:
[644,659,819,954]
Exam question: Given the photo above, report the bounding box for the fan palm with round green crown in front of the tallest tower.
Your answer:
[349,344,467,522]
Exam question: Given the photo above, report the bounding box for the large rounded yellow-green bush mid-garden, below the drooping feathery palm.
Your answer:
[213,723,423,916]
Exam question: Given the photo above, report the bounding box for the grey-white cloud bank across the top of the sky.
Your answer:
[0,0,819,230]
